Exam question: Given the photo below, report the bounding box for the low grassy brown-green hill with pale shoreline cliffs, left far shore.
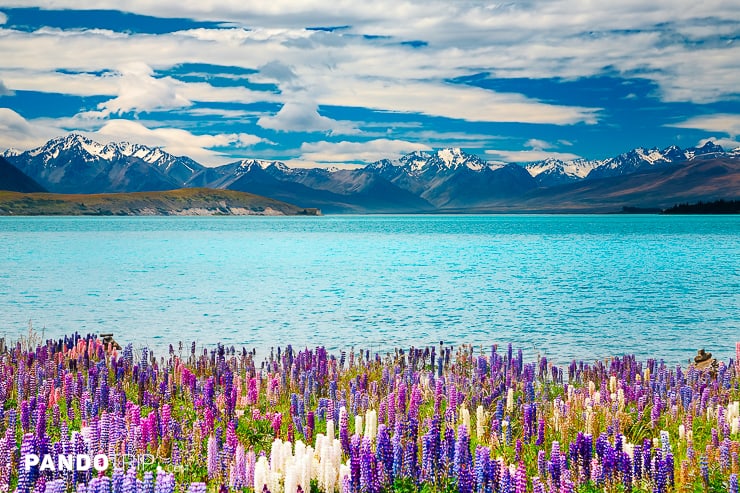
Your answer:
[0,188,316,216]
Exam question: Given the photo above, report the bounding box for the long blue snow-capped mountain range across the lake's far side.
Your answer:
[0,134,740,213]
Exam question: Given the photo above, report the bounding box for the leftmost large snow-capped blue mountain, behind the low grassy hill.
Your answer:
[3,133,202,193]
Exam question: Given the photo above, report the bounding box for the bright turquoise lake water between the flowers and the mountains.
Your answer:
[0,215,740,363]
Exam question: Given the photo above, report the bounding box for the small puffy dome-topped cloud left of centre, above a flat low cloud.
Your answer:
[257,101,360,135]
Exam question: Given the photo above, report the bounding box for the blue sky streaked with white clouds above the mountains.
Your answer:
[0,0,740,167]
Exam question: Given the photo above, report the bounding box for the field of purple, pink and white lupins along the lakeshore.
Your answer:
[0,334,740,493]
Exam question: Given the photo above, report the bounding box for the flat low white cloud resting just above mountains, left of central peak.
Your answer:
[299,139,430,165]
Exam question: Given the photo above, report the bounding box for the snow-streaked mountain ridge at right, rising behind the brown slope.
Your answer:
[525,142,724,187]
